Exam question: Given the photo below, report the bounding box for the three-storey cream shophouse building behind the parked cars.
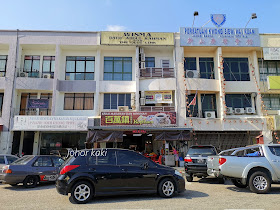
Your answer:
[0,28,277,162]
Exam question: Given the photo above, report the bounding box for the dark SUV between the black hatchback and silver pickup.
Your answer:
[184,145,221,182]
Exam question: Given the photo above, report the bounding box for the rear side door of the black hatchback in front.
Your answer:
[88,150,123,194]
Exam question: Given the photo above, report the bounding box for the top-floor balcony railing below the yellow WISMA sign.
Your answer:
[140,67,175,78]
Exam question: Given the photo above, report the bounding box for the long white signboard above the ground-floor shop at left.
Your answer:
[13,116,88,131]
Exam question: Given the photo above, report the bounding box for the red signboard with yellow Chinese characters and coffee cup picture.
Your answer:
[101,112,176,127]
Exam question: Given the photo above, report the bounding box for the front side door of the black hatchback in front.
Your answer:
[117,150,157,191]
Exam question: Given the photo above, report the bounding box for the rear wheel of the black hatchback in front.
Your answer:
[70,181,93,204]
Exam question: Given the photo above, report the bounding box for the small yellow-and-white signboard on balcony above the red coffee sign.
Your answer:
[145,90,172,104]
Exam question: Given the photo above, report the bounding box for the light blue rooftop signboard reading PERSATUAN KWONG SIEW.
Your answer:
[180,27,260,47]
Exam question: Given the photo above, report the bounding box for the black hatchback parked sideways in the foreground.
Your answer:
[56,149,185,204]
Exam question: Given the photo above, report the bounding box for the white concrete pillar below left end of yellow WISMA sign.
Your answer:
[93,49,103,116]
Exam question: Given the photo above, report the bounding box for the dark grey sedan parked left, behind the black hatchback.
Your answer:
[0,155,64,187]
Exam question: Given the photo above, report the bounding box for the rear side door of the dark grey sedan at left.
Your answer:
[32,156,56,181]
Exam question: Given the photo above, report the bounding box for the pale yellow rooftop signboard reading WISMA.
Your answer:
[101,31,174,45]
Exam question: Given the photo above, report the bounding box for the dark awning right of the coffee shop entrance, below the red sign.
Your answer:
[155,131,190,141]
